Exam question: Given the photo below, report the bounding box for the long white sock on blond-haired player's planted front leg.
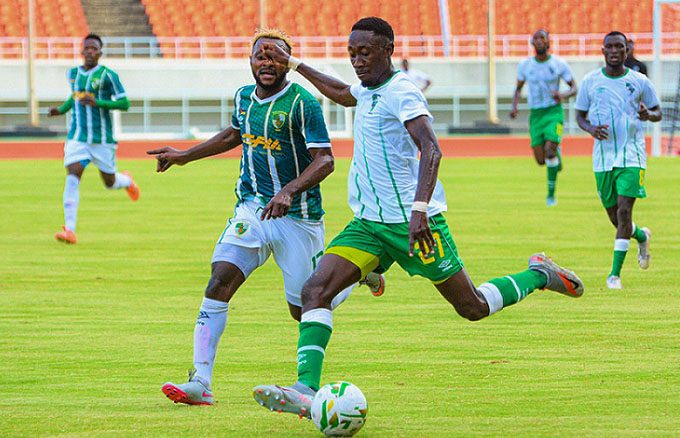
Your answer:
[194,297,229,389]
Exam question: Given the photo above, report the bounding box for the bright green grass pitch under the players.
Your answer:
[0,157,680,438]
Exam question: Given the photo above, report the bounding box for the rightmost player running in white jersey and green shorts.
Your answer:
[575,31,661,289]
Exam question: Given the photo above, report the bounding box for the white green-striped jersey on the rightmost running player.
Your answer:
[574,68,659,172]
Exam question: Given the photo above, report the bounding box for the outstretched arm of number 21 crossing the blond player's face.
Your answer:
[262,43,357,106]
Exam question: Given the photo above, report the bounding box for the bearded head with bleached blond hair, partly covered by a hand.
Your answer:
[250,29,293,90]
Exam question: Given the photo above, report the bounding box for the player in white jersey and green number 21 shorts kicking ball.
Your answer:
[253,17,583,417]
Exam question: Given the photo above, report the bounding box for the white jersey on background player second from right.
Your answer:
[517,55,574,109]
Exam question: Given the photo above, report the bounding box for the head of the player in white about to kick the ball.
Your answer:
[347,17,394,87]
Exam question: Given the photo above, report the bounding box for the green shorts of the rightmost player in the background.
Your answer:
[595,167,647,208]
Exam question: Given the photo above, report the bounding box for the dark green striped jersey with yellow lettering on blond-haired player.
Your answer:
[231,82,331,220]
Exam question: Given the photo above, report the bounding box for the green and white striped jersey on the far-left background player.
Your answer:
[67,65,125,144]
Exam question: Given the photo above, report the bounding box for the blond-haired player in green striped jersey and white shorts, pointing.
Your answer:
[148,29,384,405]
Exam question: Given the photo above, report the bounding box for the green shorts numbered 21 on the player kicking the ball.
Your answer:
[326,214,463,284]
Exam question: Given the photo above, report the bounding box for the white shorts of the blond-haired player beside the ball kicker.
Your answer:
[211,201,325,306]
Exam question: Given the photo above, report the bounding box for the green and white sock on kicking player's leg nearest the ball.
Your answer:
[297,309,333,391]
